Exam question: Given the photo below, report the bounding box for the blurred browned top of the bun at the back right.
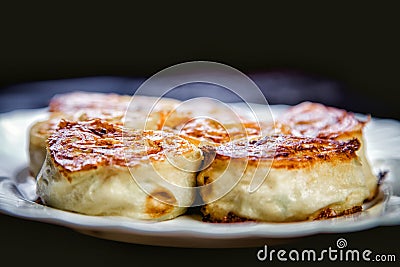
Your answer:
[276,102,369,139]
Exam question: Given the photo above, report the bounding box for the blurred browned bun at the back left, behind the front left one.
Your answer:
[29,92,182,177]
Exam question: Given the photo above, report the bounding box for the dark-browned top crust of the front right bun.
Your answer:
[216,135,360,169]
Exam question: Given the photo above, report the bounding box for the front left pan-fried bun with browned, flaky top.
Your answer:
[37,119,202,220]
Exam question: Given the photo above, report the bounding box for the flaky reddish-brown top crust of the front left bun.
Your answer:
[48,119,193,172]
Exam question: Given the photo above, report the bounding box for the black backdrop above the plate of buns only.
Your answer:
[0,3,400,119]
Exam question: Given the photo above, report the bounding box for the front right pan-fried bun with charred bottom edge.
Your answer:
[197,135,372,222]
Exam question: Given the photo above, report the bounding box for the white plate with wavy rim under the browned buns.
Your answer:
[0,106,400,247]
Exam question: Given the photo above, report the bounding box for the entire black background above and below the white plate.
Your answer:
[0,2,400,266]
